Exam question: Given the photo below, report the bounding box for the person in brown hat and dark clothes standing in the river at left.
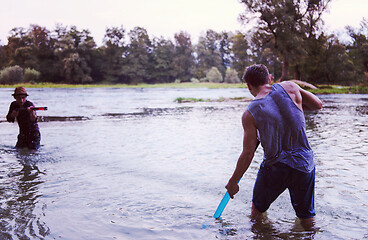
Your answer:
[6,87,41,149]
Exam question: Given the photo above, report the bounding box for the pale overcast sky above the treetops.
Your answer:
[0,0,368,45]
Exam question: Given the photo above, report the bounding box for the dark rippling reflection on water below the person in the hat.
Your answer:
[0,147,50,240]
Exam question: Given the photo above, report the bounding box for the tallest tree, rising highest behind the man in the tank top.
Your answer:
[241,0,331,80]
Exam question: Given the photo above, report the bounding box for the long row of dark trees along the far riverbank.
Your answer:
[0,0,368,85]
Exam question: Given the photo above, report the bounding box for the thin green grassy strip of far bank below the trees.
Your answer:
[0,82,368,94]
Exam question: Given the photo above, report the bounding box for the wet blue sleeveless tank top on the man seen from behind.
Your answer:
[248,84,314,172]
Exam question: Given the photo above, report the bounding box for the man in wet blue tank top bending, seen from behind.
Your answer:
[226,65,322,229]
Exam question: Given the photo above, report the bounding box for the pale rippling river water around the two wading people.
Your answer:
[0,88,368,240]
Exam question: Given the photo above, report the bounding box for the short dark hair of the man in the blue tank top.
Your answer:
[242,64,270,87]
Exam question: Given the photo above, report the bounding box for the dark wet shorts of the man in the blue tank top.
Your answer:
[252,163,316,218]
